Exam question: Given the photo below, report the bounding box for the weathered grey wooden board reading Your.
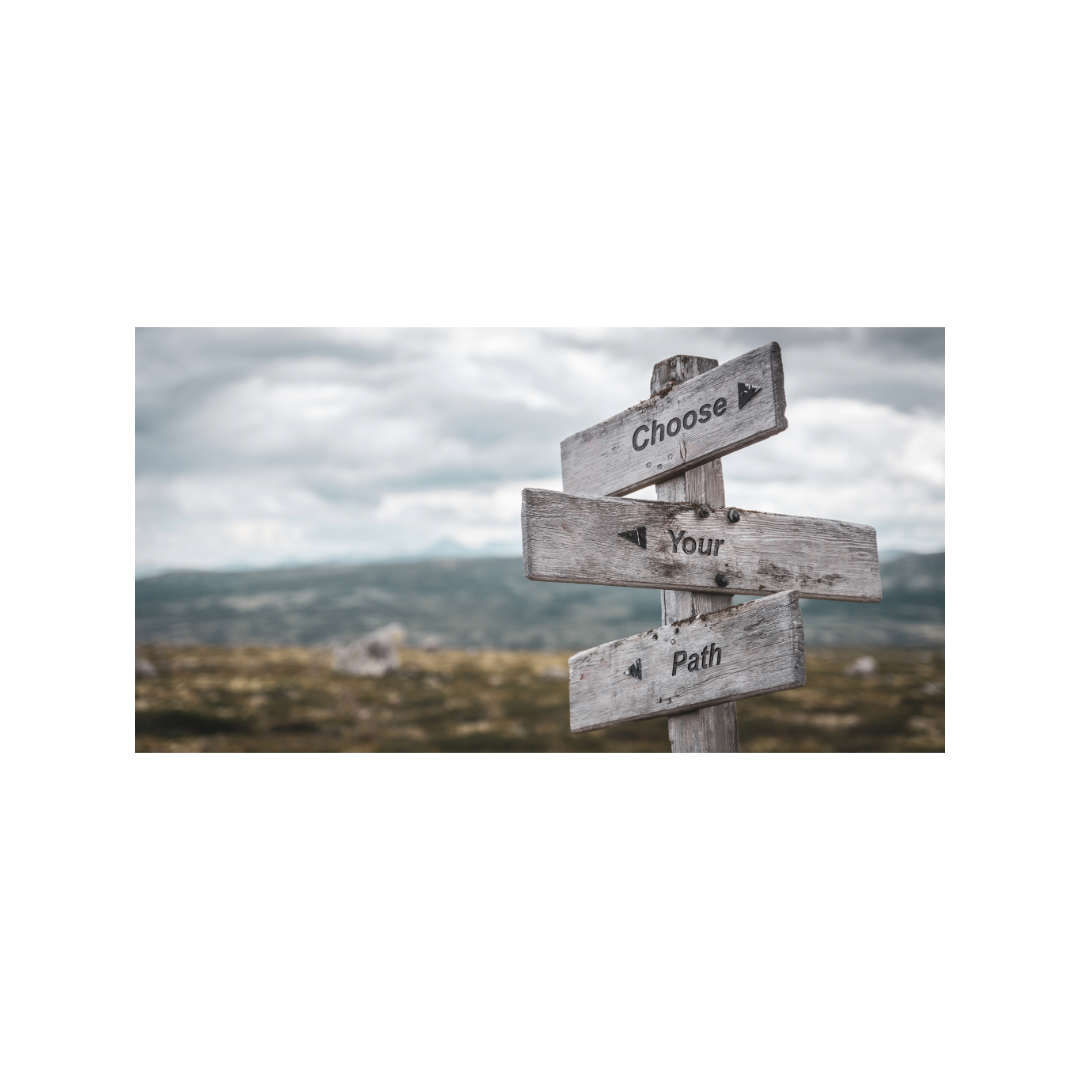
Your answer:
[522,488,881,604]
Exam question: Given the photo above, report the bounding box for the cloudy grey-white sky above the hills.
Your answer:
[135,327,945,575]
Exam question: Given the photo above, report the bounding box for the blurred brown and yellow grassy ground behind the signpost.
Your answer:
[135,645,945,754]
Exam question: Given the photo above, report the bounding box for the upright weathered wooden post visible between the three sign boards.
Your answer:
[650,356,739,754]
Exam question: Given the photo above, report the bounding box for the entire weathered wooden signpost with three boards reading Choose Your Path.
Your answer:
[522,341,881,753]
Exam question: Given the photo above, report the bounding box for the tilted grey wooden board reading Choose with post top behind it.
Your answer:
[562,341,787,496]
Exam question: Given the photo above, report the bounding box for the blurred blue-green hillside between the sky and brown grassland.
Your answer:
[135,552,945,651]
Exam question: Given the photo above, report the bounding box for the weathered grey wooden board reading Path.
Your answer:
[570,589,806,731]
